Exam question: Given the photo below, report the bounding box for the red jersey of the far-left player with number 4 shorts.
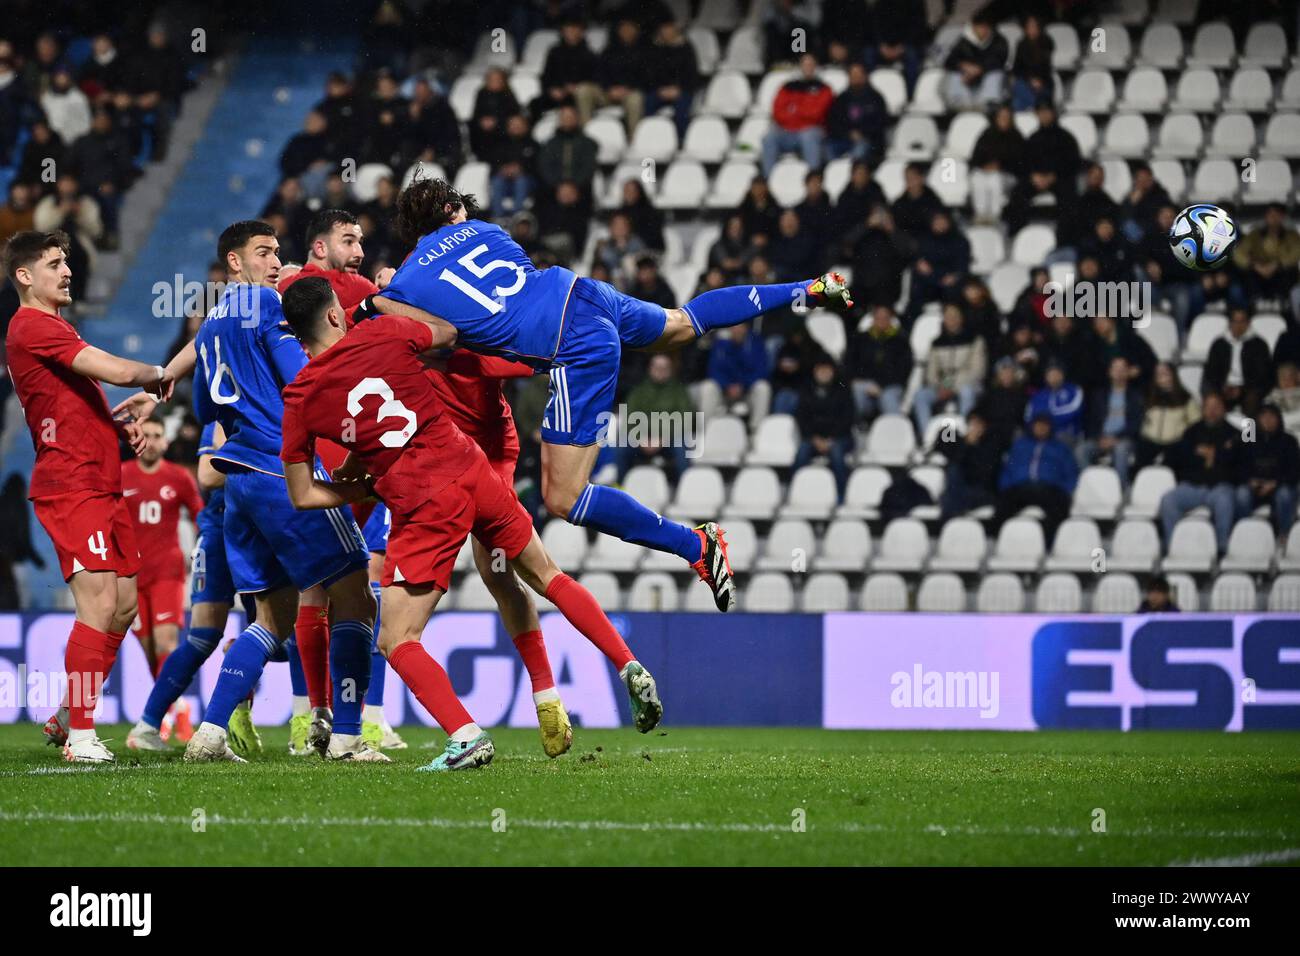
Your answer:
[5,307,122,498]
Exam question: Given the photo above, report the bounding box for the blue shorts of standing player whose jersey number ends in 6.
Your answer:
[225,471,371,594]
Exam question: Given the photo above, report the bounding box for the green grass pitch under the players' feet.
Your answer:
[0,724,1300,866]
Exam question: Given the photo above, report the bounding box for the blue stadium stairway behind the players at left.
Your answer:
[0,38,356,607]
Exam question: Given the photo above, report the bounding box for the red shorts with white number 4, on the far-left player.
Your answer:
[31,492,140,581]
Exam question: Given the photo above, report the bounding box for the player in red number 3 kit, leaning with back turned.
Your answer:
[281,278,663,770]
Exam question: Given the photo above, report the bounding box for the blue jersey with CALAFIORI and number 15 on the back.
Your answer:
[381,219,577,368]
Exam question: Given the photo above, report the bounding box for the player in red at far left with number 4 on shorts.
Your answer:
[4,230,172,762]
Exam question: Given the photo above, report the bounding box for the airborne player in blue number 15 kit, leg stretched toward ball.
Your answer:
[361,179,853,611]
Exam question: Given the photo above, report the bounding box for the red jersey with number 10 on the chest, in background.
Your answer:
[122,459,203,588]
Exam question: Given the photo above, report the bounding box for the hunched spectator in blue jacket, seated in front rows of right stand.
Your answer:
[993,412,1079,548]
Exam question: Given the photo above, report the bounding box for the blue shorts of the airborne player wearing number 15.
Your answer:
[541,278,668,445]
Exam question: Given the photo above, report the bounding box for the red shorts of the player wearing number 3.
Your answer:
[382,459,533,591]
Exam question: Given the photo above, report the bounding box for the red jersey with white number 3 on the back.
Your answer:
[280,315,482,514]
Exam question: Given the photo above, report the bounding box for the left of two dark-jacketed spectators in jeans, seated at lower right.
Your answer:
[1160,392,1242,554]
